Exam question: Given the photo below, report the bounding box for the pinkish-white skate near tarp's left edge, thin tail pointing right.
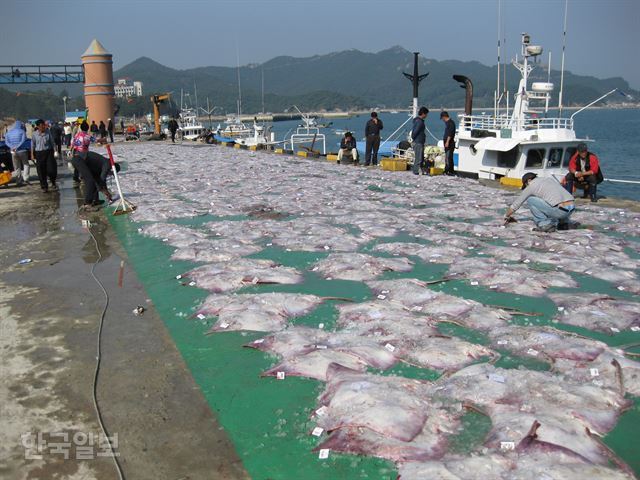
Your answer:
[196,293,322,332]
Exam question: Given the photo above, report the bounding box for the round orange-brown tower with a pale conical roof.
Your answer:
[80,39,115,124]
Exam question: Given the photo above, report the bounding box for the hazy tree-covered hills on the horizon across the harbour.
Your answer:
[0,46,640,118]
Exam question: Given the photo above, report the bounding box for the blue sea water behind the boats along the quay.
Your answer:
[273,109,640,201]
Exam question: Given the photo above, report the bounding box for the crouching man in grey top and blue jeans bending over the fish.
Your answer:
[504,172,576,232]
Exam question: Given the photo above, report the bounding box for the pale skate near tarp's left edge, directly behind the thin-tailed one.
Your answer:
[183,258,303,293]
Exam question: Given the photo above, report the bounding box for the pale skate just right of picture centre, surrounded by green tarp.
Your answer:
[315,253,413,282]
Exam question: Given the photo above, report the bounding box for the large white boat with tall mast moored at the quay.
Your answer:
[452,34,589,180]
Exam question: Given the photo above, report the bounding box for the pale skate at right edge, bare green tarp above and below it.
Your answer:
[549,293,640,333]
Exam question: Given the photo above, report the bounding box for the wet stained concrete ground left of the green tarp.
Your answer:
[0,171,248,480]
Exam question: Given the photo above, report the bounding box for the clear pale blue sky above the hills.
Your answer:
[0,0,640,89]
